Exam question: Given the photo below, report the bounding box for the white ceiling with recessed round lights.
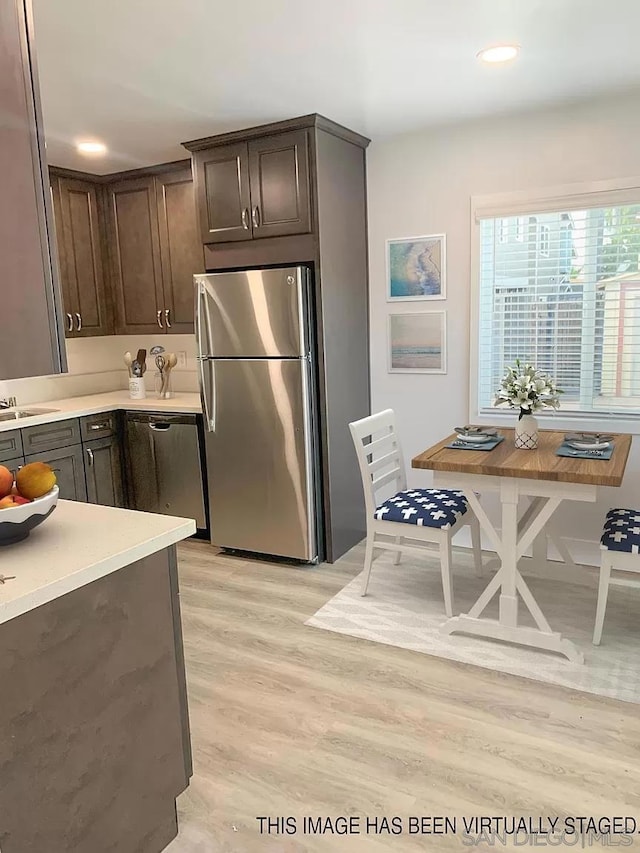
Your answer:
[33,0,640,173]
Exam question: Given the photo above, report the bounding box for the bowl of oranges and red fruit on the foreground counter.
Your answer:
[0,462,58,545]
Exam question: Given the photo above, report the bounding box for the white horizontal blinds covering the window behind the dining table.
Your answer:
[478,206,640,415]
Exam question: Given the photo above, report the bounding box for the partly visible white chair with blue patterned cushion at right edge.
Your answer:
[593,508,640,646]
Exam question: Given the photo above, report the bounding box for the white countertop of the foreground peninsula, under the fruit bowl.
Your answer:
[0,501,196,623]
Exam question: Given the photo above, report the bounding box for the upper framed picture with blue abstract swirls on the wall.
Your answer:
[387,234,446,302]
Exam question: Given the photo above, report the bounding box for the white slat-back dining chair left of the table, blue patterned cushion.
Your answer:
[349,409,482,616]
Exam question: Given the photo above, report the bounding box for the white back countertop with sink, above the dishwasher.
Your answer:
[0,391,202,432]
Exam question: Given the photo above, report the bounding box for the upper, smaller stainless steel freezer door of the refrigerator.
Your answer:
[194,267,308,358]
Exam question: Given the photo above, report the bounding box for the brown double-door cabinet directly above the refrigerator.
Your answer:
[193,130,311,243]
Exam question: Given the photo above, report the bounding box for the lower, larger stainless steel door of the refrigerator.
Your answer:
[202,359,317,561]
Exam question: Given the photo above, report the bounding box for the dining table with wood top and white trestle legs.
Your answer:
[411,428,631,663]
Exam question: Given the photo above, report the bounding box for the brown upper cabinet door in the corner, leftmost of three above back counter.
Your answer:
[51,177,113,338]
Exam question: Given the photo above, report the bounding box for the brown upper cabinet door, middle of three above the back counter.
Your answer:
[107,177,166,335]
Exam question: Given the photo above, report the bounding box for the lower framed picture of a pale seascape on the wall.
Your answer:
[389,311,447,373]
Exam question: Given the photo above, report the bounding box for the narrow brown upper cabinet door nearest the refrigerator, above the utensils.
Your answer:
[155,168,204,334]
